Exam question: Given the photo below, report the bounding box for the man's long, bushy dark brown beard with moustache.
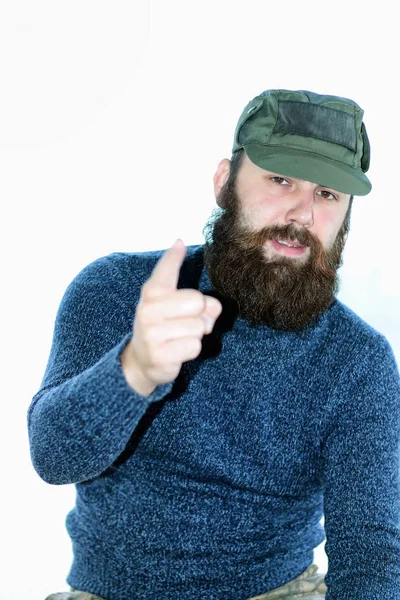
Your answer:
[204,173,351,331]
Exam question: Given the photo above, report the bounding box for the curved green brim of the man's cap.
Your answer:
[244,144,372,196]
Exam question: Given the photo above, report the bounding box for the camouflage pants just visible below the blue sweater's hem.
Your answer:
[46,565,327,600]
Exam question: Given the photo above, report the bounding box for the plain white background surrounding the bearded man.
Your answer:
[0,0,400,600]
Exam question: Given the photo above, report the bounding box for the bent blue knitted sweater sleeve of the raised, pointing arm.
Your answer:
[28,255,172,484]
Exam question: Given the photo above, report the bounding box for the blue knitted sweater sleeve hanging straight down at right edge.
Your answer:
[323,334,400,600]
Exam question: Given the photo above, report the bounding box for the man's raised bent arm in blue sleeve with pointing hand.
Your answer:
[28,243,221,483]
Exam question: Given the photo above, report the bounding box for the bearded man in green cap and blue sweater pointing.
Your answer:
[29,90,400,600]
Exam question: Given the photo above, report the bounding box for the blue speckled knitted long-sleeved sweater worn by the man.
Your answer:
[28,246,400,600]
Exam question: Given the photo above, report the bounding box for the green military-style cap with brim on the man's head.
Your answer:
[232,90,371,196]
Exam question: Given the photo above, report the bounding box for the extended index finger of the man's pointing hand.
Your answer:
[146,238,186,297]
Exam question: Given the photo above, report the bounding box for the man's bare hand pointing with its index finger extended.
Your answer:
[121,240,222,396]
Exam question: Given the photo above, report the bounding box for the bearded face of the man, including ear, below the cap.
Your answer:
[204,156,350,331]
